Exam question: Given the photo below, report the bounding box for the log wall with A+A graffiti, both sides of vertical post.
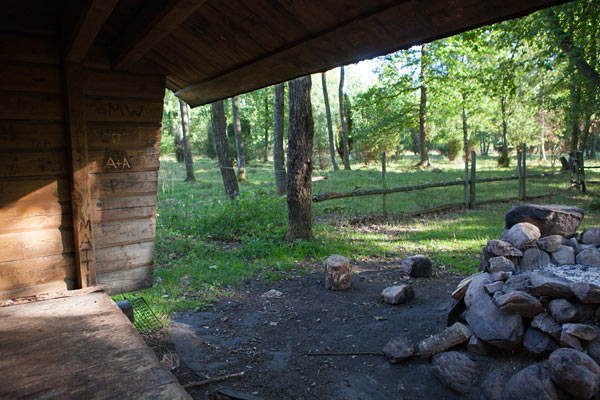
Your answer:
[0,26,165,299]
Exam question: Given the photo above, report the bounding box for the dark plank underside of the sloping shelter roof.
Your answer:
[8,0,561,106]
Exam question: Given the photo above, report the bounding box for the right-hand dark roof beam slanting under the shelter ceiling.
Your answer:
[113,0,206,70]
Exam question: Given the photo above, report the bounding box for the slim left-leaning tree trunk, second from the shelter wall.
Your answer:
[211,100,240,199]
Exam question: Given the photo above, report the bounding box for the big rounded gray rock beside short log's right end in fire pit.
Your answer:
[466,284,524,350]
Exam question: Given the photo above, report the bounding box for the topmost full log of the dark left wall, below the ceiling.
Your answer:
[0,32,60,65]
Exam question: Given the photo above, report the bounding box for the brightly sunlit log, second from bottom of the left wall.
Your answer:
[0,229,74,262]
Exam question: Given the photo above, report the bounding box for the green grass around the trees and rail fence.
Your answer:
[127,152,600,317]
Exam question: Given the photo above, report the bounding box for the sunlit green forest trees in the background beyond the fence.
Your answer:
[161,0,600,179]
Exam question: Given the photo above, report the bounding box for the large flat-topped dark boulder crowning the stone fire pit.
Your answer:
[504,204,584,237]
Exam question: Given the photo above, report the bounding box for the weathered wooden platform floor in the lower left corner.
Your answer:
[0,288,191,400]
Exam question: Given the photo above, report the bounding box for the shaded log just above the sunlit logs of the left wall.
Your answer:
[0,151,69,178]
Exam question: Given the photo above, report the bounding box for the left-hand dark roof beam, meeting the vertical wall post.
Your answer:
[65,0,119,62]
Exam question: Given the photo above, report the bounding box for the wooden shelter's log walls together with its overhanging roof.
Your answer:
[0,0,556,398]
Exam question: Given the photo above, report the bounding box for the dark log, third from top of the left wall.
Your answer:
[0,92,64,121]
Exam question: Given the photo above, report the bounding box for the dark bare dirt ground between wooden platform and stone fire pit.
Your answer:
[155,262,528,400]
